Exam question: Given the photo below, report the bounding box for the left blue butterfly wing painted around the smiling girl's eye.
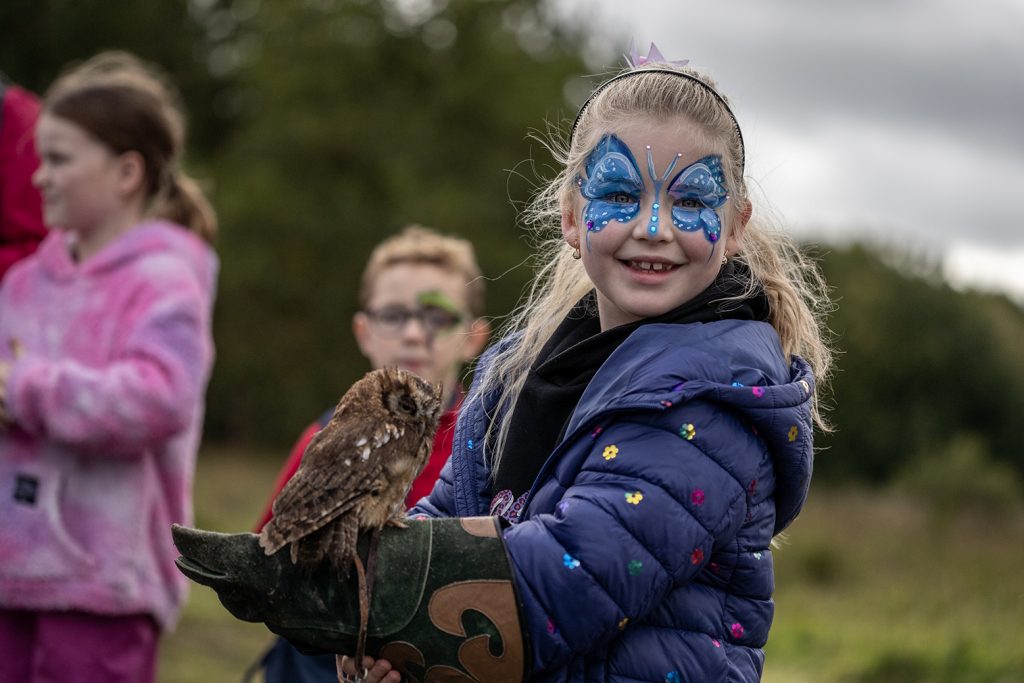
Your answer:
[577,133,644,251]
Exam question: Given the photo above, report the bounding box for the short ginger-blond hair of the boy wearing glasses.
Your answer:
[359,225,484,317]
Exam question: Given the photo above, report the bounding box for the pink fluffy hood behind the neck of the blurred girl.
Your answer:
[39,220,218,291]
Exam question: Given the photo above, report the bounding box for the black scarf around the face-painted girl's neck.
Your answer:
[493,261,769,498]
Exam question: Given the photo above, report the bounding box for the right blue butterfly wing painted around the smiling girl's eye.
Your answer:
[669,155,729,260]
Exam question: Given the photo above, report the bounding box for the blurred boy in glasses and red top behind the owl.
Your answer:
[247,225,490,683]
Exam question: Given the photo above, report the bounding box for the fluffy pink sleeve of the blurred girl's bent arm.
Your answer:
[8,270,213,457]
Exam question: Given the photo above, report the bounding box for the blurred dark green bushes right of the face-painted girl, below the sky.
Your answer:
[815,242,1024,481]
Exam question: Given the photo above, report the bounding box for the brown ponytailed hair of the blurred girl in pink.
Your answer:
[43,51,217,244]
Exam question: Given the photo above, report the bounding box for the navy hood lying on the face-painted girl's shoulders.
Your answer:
[567,321,814,533]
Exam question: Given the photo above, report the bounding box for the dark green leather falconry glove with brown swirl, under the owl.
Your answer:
[172,517,527,683]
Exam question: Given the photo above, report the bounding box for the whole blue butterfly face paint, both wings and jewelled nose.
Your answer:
[577,133,729,259]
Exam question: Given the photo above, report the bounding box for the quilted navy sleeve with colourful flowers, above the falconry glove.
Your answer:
[505,409,748,673]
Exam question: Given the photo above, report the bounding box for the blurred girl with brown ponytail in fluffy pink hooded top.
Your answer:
[0,53,217,683]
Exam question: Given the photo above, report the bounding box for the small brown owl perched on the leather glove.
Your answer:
[259,368,441,575]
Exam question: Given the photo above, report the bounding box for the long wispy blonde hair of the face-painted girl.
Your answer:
[479,63,833,471]
